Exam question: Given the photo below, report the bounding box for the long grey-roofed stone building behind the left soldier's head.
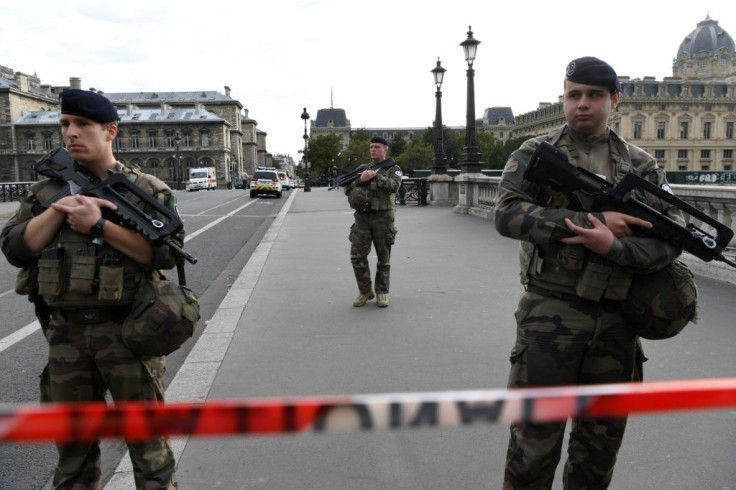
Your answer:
[0,71,272,188]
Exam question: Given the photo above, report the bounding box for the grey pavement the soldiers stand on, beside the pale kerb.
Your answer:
[0,192,736,490]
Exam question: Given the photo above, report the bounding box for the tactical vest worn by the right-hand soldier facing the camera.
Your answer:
[521,128,633,301]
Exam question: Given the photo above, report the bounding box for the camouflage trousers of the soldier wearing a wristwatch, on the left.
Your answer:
[41,320,177,490]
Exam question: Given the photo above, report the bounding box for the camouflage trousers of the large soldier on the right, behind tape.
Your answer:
[503,292,643,490]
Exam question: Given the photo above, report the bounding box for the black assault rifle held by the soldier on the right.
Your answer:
[524,141,736,268]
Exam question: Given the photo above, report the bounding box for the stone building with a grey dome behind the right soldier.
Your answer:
[513,17,736,172]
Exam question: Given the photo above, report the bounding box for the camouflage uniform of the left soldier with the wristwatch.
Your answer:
[0,163,183,489]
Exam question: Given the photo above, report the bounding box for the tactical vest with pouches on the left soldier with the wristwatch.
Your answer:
[26,164,161,308]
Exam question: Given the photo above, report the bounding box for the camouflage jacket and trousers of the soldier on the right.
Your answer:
[495,125,682,489]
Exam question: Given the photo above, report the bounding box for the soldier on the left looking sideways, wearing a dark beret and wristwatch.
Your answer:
[0,89,184,489]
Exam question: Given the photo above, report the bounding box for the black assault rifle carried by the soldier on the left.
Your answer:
[33,148,197,264]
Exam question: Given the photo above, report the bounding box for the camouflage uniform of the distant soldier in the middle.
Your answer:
[345,158,402,294]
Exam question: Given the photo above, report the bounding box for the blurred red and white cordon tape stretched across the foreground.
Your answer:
[0,378,736,443]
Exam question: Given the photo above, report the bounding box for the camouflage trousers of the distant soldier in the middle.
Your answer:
[349,210,397,293]
